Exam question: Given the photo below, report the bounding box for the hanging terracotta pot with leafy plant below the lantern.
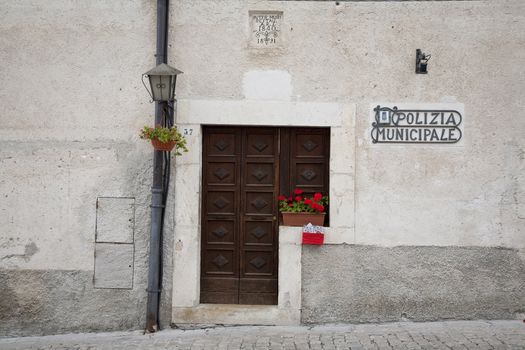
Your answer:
[140,125,188,156]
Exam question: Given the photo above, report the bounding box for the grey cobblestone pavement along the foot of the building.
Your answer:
[0,321,525,350]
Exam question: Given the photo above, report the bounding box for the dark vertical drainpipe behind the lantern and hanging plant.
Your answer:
[146,0,169,332]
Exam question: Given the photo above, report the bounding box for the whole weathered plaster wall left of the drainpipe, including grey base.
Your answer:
[0,0,172,335]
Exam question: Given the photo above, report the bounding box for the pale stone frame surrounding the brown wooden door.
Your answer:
[171,100,355,325]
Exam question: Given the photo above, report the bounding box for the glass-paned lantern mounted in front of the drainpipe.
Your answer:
[142,63,182,101]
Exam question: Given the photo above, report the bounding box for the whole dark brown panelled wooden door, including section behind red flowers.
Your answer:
[200,127,329,305]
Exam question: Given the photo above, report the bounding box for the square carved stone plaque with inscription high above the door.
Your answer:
[250,11,283,47]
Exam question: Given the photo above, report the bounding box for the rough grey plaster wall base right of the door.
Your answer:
[302,245,525,323]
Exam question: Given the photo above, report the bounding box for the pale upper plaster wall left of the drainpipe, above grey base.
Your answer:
[0,0,156,270]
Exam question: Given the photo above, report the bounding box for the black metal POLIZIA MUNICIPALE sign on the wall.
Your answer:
[371,106,463,143]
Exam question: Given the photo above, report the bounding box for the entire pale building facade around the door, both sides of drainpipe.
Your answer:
[0,0,525,335]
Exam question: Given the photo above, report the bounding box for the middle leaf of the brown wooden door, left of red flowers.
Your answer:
[239,128,279,304]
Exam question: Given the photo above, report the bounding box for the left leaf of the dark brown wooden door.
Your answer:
[201,128,241,304]
